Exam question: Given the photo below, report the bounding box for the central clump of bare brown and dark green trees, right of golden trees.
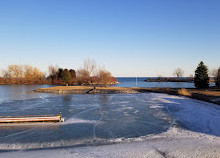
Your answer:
[48,58,117,86]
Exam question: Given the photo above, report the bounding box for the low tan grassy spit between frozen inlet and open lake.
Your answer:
[35,86,220,105]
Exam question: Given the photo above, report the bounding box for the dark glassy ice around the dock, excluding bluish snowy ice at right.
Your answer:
[0,87,173,149]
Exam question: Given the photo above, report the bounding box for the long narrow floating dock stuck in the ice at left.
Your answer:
[0,113,64,124]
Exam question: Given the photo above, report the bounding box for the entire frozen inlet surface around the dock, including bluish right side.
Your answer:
[0,82,220,150]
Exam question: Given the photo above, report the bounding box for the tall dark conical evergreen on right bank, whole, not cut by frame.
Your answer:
[194,61,209,88]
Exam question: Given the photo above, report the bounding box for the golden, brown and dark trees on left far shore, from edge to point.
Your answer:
[0,58,117,86]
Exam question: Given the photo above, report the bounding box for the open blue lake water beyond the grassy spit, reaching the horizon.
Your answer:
[113,77,214,88]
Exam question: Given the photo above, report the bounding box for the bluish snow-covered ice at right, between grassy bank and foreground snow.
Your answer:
[153,94,220,136]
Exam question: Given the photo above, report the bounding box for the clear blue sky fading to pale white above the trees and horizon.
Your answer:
[0,0,220,76]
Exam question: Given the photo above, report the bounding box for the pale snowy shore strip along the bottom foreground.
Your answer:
[0,127,220,158]
